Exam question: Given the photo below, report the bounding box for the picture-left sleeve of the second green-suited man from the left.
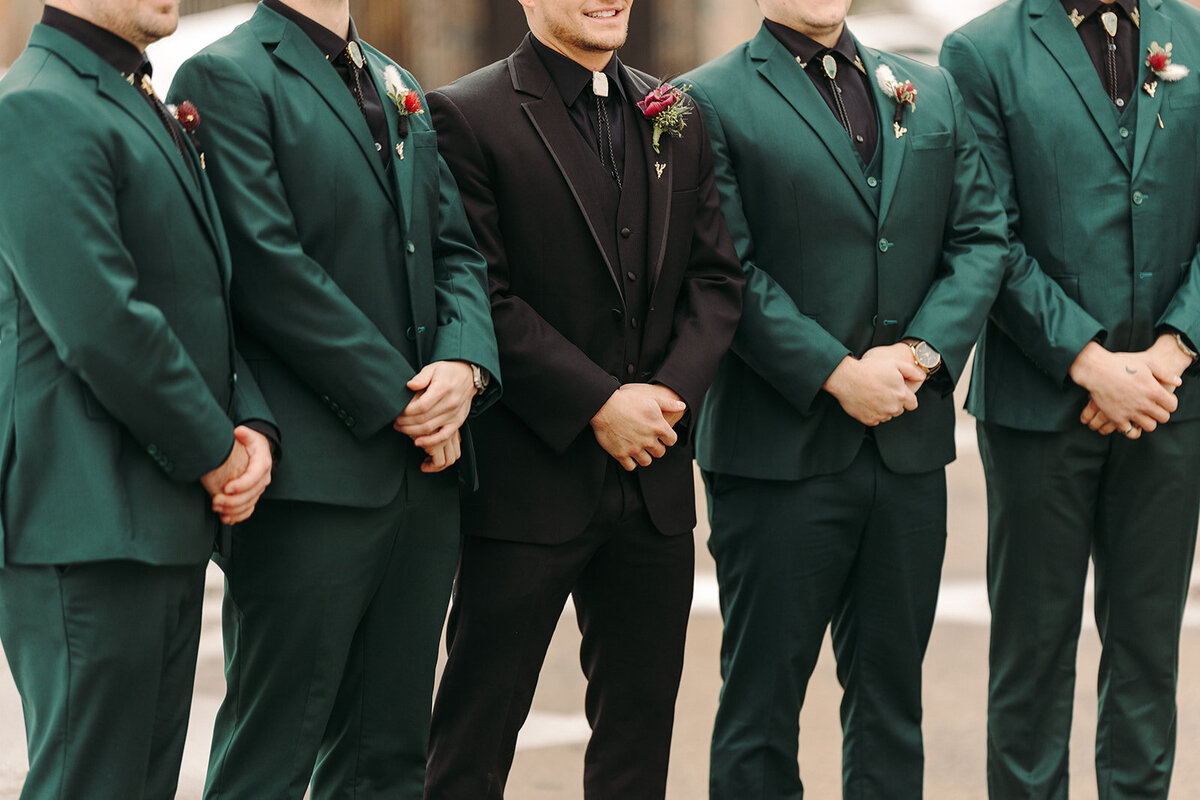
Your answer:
[170,54,416,439]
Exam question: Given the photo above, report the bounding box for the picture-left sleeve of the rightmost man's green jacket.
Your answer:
[941,32,1105,385]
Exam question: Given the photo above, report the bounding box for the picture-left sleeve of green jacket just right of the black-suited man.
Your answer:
[691,85,851,414]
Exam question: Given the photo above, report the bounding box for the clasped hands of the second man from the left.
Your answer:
[392,361,475,473]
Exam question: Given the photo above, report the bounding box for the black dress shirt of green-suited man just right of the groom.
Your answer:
[766,19,880,164]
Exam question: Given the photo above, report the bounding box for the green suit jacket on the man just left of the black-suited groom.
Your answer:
[170,6,499,507]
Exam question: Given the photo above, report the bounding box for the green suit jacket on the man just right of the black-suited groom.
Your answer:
[682,28,1006,480]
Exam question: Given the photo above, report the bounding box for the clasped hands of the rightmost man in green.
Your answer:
[1070,333,1192,439]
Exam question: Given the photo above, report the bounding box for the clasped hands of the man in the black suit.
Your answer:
[592,384,688,471]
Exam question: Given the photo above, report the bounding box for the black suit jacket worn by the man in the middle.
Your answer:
[428,37,743,543]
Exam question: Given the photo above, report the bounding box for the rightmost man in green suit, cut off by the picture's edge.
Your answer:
[942,0,1200,800]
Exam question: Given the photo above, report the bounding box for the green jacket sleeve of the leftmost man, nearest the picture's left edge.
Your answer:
[0,91,233,482]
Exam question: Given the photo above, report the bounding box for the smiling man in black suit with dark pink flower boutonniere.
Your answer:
[426,0,743,800]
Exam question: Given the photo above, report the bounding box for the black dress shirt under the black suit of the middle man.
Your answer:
[529,36,641,185]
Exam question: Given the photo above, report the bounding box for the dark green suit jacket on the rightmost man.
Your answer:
[942,0,1200,431]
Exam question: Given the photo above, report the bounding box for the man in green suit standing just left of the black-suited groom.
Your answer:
[172,0,499,800]
